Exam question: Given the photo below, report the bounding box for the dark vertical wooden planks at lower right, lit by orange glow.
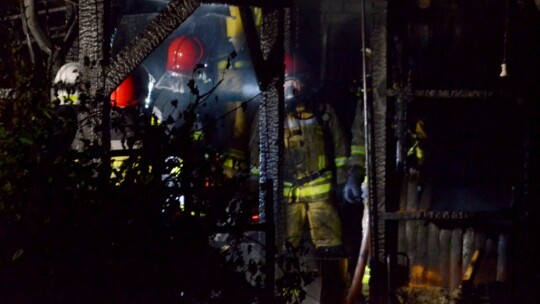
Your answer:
[397,174,510,289]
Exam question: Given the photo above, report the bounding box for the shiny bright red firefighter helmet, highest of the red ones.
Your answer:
[167,35,204,74]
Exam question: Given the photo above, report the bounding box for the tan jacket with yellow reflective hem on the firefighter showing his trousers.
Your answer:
[250,105,347,200]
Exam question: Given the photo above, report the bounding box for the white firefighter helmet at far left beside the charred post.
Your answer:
[53,62,81,105]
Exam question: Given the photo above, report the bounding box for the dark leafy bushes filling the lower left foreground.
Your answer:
[0,4,315,303]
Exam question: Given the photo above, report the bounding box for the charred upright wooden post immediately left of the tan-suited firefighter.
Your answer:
[242,2,285,303]
